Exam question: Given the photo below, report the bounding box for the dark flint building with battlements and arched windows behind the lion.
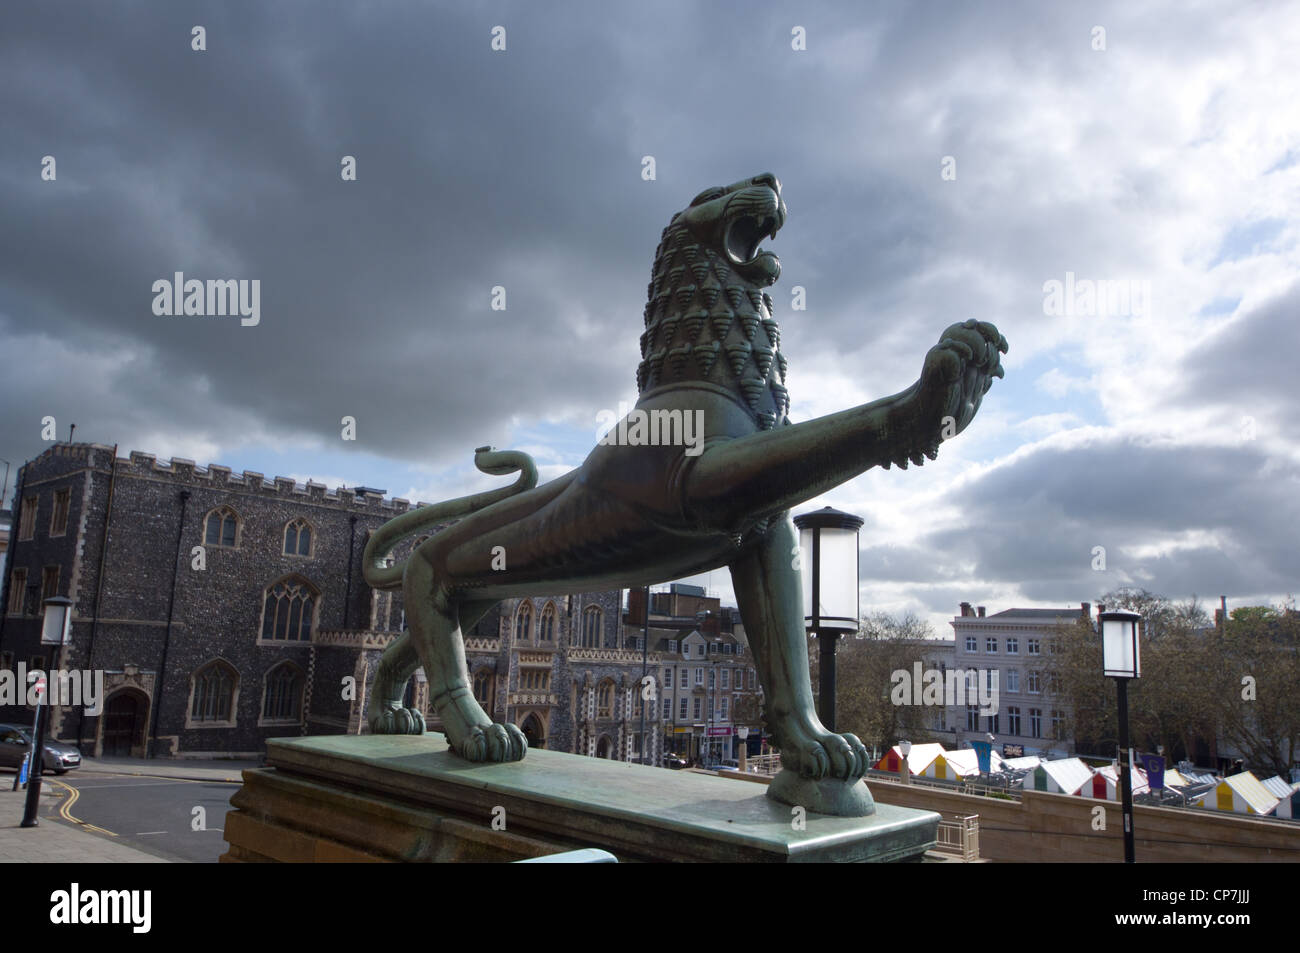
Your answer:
[0,443,681,761]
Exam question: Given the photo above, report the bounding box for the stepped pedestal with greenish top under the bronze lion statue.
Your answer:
[221,733,939,863]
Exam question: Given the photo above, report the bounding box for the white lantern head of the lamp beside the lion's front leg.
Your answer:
[794,507,862,632]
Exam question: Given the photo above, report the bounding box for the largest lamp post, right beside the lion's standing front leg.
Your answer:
[794,507,862,731]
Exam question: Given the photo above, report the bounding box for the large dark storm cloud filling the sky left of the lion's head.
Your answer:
[0,3,1128,473]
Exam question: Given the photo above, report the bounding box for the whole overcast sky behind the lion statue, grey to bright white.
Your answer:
[0,0,1300,634]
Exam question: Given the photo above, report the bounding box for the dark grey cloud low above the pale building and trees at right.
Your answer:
[894,438,1300,611]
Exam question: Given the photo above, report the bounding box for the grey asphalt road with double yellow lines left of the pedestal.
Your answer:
[44,771,239,863]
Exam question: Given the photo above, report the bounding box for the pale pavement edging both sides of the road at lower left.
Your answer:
[0,758,260,863]
